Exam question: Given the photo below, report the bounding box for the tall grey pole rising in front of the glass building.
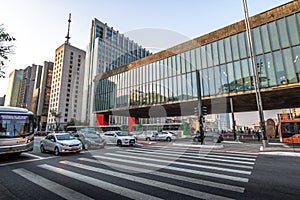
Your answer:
[243,0,268,148]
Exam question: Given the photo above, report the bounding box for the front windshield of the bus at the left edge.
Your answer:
[0,114,33,138]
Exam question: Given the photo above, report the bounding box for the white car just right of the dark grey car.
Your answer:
[102,131,136,146]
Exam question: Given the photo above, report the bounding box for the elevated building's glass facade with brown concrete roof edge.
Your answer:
[94,1,300,122]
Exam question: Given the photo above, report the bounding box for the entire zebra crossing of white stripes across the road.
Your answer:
[12,146,258,199]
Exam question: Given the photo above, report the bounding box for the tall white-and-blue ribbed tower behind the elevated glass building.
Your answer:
[83,19,151,125]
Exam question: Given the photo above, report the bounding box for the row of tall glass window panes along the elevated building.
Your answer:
[95,13,300,110]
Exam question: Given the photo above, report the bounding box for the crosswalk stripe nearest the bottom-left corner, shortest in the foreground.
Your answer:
[13,168,92,200]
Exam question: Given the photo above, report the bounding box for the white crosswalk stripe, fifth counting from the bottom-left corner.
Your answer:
[93,155,249,182]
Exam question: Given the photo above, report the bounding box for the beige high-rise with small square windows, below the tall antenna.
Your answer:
[47,43,85,129]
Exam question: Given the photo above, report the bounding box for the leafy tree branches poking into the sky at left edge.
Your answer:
[0,24,16,78]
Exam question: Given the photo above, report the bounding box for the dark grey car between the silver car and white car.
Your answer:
[74,132,106,149]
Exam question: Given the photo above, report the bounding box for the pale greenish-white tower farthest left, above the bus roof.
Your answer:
[4,69,23,107]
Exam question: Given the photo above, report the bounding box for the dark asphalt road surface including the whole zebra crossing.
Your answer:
[0,140,300,200]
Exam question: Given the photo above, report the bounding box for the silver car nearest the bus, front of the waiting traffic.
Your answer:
[40,132,82,156]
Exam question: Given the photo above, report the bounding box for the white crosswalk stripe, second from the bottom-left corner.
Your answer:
[39,164,160,200]
